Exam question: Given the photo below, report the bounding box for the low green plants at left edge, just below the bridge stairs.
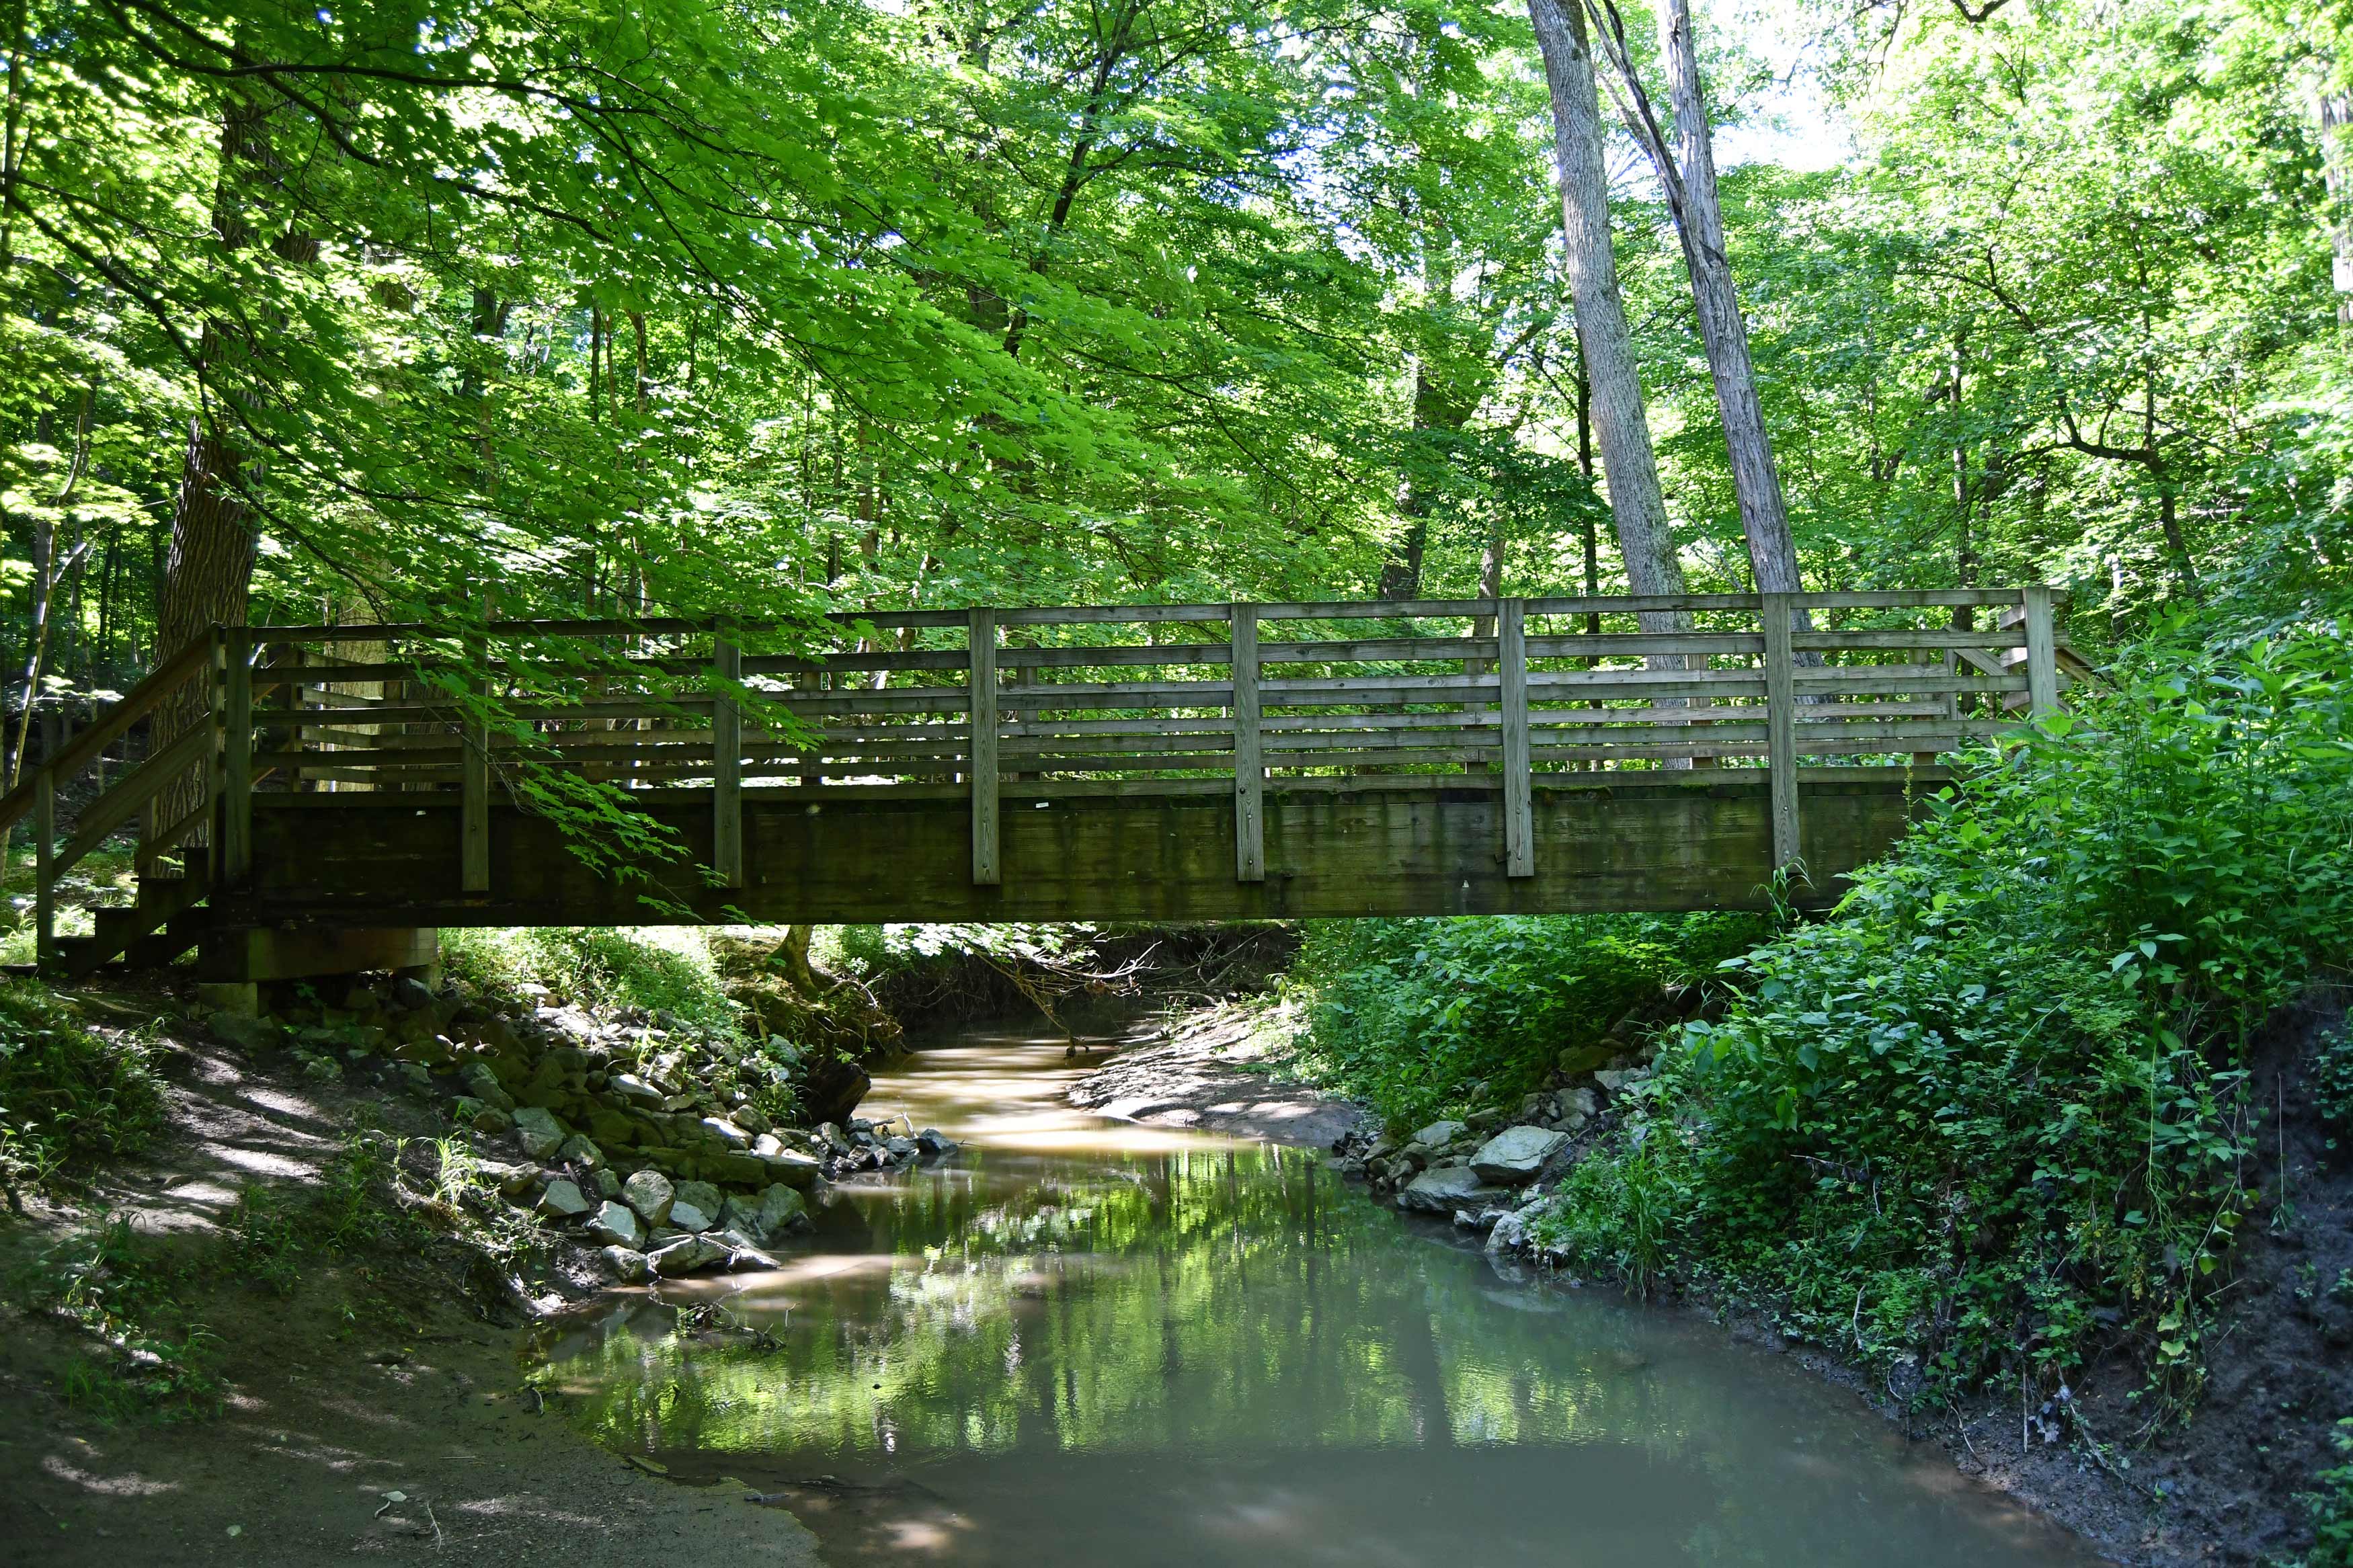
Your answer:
[0,981,163,1187]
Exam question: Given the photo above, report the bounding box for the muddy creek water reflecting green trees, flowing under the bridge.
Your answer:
[536,1034,2094,1568]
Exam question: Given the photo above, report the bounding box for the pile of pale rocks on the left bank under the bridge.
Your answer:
[212,978,955,1284]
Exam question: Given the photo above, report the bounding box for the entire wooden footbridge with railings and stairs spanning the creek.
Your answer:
[0,587,2069,981]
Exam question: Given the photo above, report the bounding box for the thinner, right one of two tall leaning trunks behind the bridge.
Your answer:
[1659,0,1802,592]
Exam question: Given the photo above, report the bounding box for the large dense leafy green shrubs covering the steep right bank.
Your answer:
[1539,634,2353,1399]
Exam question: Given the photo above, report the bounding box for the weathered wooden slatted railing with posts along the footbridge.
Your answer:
[221,587,2066,889]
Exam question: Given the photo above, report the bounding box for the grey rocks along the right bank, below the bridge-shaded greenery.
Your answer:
[1332,987,1699,1253]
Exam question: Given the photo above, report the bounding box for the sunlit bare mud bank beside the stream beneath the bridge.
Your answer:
[1071,1009,1369,1147]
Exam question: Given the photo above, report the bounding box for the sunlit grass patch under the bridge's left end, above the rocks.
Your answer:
[442,926,739,1037]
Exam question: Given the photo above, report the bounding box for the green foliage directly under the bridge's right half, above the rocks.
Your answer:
[1292,915,1763,1126]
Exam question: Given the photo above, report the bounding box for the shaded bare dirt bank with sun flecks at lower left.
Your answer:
[0,992,817,1568]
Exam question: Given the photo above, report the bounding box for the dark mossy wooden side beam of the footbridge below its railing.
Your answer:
[214,769,1942,929]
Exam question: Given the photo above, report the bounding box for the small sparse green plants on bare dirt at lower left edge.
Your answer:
[12,1215,221,1420]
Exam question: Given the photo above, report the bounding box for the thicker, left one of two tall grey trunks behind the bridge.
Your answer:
[1527,0,1689,630]
